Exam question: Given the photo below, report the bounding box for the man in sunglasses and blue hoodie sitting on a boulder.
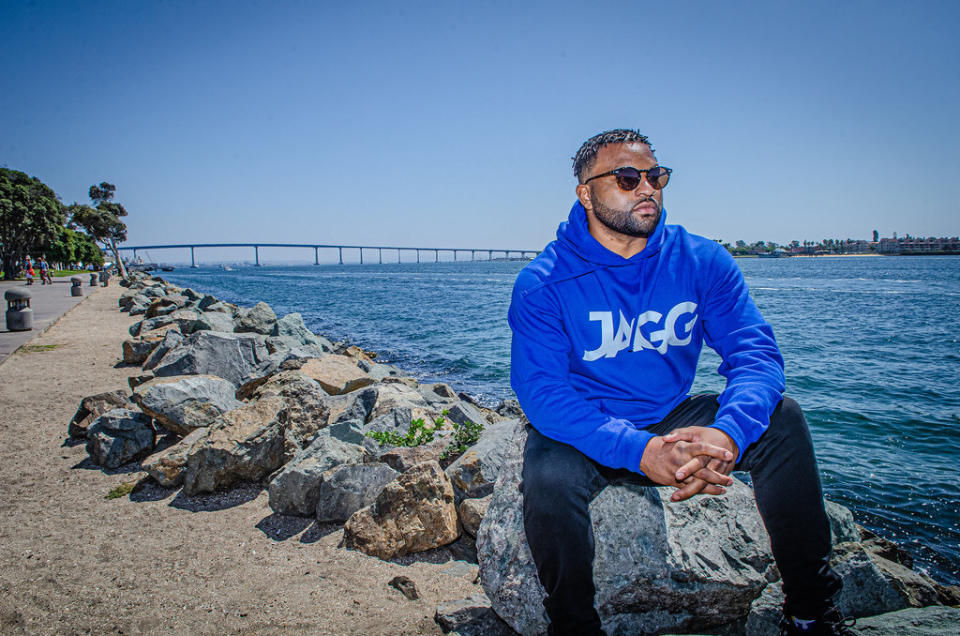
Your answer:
[509,130,847,634]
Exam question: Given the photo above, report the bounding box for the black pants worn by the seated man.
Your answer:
[522,394,840,634]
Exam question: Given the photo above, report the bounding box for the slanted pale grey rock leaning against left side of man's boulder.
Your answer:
[446,420,518,501]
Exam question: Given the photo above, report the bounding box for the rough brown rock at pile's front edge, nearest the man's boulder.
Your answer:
[343,462,460,559]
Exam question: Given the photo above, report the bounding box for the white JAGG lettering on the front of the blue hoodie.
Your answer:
[583,301,698,362]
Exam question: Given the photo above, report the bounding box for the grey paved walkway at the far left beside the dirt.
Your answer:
[0,275,106,363]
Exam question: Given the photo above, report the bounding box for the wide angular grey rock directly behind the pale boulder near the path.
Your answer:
[154,331,267,386]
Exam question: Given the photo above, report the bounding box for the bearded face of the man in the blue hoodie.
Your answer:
[578,142,663,238]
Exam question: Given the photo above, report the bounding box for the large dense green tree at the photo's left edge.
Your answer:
[0,168,63,280]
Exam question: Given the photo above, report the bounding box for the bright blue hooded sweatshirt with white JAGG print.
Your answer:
[509,202,784,472]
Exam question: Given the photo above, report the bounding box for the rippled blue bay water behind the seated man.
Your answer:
[164,256,960,584]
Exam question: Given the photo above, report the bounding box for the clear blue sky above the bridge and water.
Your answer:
[0,0,960,260]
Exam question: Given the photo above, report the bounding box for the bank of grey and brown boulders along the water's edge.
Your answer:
[68,274,960,634]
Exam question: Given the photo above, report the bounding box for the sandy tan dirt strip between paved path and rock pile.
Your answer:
[0,285,480,635]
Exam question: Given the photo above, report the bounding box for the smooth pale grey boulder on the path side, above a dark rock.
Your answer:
[133,375,243,435]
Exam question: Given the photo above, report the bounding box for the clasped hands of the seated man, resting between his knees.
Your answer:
[640,426,739,501]
